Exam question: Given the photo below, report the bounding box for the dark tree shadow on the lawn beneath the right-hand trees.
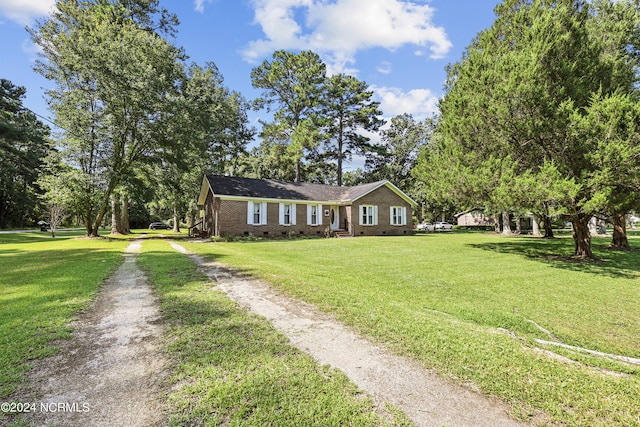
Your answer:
[468,237,640,279]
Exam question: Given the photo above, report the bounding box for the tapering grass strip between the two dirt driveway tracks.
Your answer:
[138,240,408,426]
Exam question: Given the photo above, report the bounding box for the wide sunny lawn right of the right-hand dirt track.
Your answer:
[179,233,640,426]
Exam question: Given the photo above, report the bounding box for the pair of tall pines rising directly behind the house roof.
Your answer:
[250,50,384,185]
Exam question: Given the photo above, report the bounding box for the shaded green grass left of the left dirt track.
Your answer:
[0,232,124,408]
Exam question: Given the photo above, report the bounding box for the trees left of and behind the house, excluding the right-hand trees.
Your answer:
[0,0,431,236]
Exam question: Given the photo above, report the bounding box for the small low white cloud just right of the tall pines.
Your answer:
[371,86,438,120]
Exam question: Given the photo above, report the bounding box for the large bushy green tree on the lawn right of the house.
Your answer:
[416,0,640,257]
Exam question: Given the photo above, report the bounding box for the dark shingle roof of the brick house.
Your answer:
[207,175,387,201]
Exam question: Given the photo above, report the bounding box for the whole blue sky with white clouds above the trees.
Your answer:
[0,0,499,147]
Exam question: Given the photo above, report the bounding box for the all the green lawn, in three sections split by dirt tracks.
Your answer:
[0,232,640,426]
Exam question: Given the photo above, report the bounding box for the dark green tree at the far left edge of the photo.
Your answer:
[0,79,51,228]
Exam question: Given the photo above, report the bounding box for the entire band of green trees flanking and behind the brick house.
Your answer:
[0,0,640,257]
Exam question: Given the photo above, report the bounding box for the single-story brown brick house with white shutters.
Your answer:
[198,175,416,237]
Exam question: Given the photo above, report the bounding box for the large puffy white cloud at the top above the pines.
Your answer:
[243,0,451,72]
